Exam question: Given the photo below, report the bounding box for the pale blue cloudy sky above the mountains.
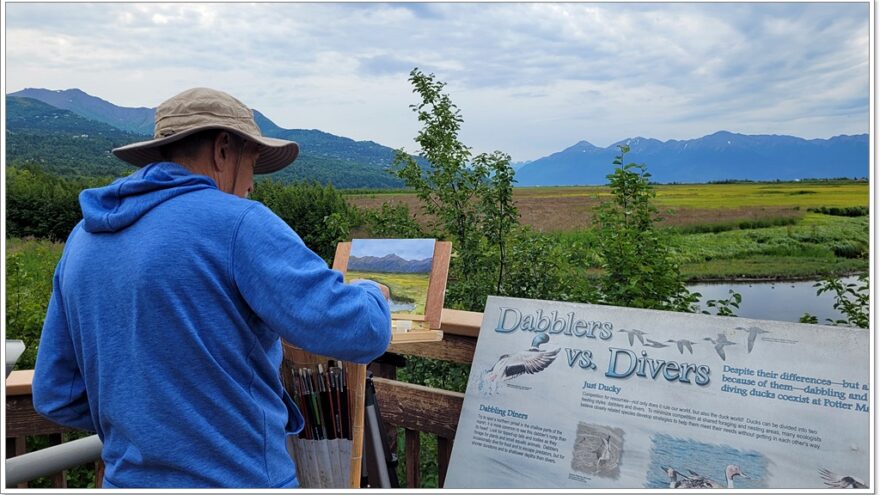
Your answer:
[5,3,870,161]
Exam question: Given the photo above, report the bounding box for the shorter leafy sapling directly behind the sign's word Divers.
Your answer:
[595,146,696,311]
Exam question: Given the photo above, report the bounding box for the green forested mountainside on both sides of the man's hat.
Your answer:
[6,91,412,189]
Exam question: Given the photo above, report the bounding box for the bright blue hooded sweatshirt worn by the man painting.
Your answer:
[33,162,391,488]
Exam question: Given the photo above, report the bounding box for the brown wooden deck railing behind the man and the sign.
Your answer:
[6,309,483,488]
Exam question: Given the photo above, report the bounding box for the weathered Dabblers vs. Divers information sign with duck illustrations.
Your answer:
[445,297,872,488]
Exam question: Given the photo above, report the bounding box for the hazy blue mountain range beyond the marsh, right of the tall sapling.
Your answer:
[516,131,868,186]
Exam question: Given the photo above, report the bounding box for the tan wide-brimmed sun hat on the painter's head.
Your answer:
[113,88,299,174]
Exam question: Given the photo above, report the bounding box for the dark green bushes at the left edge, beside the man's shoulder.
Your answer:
[6,166,111,241]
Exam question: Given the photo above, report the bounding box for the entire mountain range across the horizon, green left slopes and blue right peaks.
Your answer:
[6,88,869,188]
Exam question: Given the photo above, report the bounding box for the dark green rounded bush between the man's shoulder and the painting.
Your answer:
[250,180,357,264]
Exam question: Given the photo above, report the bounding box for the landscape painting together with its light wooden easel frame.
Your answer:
[333,239,452,343]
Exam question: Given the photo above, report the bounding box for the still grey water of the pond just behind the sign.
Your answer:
[688,277,858,324]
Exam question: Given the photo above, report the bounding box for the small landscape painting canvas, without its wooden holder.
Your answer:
[345,239,435,317]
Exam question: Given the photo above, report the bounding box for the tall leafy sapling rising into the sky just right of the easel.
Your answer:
[394,69,518,311]
